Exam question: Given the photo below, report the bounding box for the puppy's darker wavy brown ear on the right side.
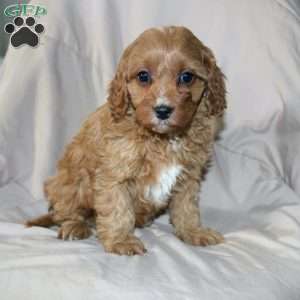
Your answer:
[202,47,226,117]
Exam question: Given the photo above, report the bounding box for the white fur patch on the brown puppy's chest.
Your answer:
[145,165,182,205]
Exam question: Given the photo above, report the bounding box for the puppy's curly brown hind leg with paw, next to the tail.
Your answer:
[35,169,94,240]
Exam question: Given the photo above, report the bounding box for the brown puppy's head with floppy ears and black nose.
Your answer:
[108,26,226,134]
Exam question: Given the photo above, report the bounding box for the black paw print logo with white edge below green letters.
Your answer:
[4,17,45,47]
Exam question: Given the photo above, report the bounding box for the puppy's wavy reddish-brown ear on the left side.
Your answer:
[107,45,132,121]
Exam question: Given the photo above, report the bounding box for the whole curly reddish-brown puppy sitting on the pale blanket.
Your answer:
[27,26,226,255]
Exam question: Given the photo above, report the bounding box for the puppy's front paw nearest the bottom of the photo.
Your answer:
[104,235,147,256]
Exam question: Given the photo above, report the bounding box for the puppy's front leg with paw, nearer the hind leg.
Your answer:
[95,183,146,255]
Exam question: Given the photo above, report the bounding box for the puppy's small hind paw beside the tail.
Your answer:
[58,220,92,240]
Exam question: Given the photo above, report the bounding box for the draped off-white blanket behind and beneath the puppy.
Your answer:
[0,0,300,300]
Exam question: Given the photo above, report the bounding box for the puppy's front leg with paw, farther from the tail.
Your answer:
[169,179,224,246]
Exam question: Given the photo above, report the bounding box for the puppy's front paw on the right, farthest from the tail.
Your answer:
[177,227,225,246]
